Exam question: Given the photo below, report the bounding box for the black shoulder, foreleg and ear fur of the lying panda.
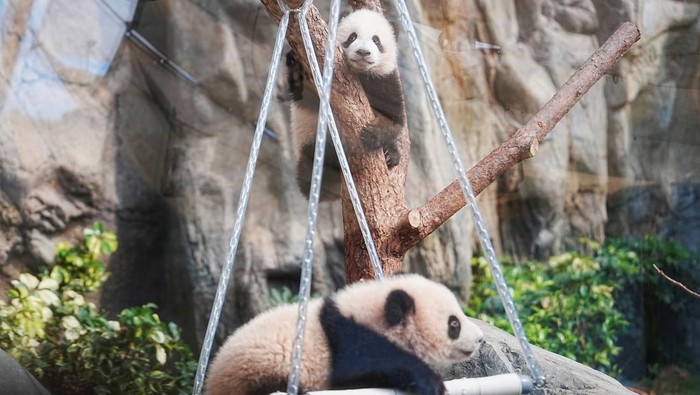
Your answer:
[320,292,446,395]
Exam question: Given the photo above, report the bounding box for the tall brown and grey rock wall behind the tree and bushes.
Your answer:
[0,0,700,376]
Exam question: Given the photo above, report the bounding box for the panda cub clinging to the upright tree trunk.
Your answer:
[287,10,406,200]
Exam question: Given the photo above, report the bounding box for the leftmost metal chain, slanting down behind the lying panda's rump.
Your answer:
[192,6,289,395]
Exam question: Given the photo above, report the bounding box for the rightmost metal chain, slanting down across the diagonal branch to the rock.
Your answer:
[394,0,546,387]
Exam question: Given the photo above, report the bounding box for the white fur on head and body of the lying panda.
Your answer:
[206,275,483,395]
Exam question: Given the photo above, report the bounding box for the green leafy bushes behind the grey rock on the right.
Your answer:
[466,236,698,375]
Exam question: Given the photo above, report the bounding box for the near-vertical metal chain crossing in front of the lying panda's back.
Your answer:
[287,0,340,395]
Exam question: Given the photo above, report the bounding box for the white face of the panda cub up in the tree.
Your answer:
[338,10,397,76]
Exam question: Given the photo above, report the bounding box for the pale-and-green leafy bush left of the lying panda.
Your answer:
[0,223,196,394]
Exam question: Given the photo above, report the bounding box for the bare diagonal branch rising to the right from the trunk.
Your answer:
[397,22,640,253]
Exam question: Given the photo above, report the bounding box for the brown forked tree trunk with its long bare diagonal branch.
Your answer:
[261,0,640,283]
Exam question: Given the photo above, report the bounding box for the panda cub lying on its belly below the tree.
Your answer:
[206,275,484,395]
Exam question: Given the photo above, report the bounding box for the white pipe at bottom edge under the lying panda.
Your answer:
[270,373,532,395]
